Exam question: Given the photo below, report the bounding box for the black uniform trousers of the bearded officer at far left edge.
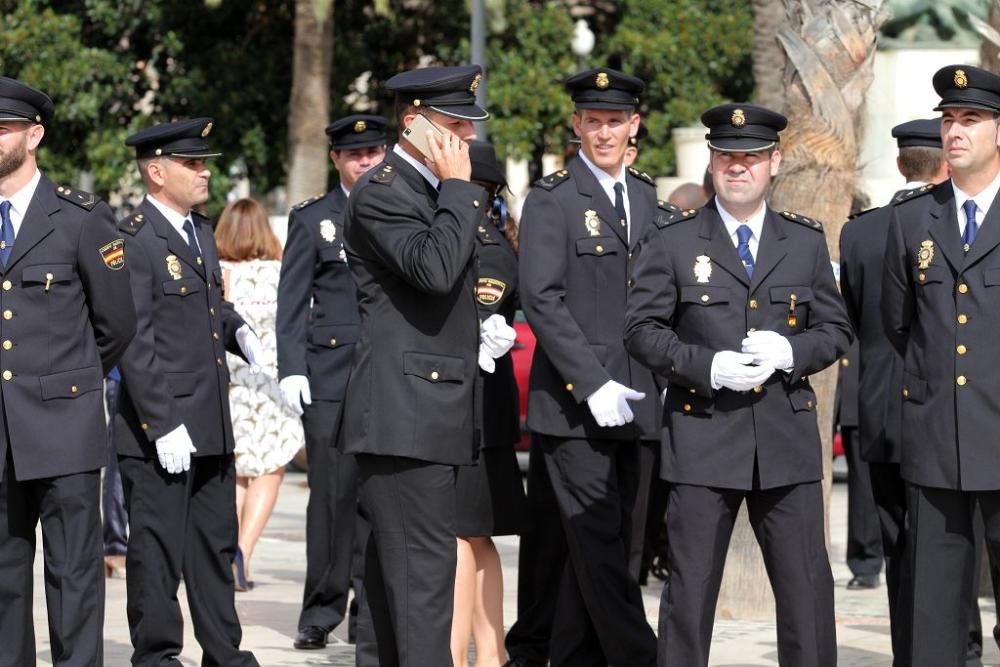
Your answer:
[0,448,104,667]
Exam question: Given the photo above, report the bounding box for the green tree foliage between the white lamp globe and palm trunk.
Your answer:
[597,0,753,176]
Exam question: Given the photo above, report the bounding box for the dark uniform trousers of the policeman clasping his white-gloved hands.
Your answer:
[659,482,837,667]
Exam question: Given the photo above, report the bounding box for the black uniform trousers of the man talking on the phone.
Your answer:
[356,454,458,667]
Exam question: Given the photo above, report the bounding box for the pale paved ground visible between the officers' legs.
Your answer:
[25,474,1000,667]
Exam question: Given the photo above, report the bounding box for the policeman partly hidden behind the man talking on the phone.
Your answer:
[276,115,386,649]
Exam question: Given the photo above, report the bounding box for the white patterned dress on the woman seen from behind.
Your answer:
[221,259,303,477]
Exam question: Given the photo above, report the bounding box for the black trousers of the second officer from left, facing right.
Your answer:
[119,454,257,667]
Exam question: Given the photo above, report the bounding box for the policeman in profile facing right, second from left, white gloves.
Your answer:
[115,118,260,666]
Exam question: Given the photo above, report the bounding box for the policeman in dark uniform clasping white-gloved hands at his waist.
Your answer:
[625,104,853,667]
